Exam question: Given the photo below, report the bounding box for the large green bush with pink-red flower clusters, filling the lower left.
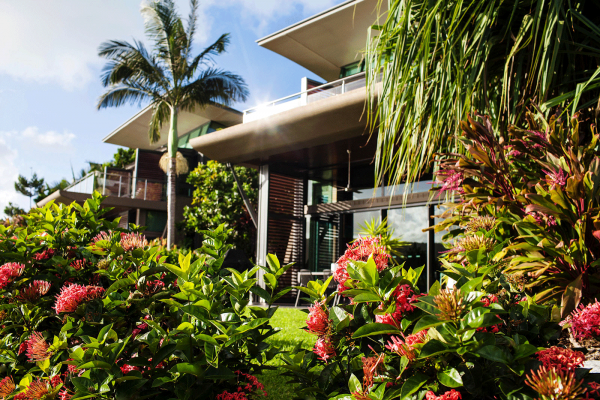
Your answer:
[0,192,290,400]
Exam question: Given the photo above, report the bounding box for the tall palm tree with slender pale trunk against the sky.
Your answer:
[98,0,248,248]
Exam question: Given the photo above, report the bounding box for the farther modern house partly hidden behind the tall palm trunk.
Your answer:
[38,105,242,242]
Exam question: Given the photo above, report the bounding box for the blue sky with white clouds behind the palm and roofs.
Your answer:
[0,0,343,216]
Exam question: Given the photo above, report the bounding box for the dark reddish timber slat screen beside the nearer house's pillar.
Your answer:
[267,173,304,301]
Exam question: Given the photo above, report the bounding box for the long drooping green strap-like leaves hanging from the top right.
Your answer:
[366,0,600,192]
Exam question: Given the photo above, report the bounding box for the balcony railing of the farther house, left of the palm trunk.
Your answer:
[65,170,167,201]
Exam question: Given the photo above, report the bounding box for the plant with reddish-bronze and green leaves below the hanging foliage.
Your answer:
[436,109,600,317]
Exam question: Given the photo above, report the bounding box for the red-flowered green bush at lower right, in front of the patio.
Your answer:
[283,236,600,400]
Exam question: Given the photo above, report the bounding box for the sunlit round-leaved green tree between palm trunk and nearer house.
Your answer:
[183,160,258,257]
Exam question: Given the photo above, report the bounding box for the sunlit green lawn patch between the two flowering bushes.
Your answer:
[258,308,317,400]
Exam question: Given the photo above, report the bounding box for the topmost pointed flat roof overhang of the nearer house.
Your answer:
[257,0,387,81]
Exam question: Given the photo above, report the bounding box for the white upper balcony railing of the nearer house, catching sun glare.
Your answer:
[244,72,366,123]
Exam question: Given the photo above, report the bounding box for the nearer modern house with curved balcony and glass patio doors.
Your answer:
[190,0,443,294]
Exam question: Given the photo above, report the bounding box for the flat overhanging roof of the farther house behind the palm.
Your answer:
[102,104,242,150]
